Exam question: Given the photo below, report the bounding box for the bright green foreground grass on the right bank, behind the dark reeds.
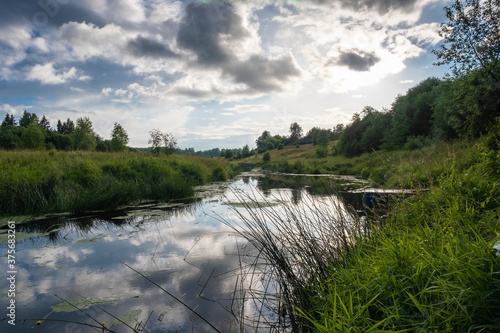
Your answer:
[301,139,500,332]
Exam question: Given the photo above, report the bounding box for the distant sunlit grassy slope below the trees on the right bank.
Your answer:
[240,141,480,188]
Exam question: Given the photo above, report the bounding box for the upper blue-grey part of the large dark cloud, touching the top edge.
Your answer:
[177,2,249,66]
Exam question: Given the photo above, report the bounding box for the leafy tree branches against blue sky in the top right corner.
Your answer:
[433,0,500,83]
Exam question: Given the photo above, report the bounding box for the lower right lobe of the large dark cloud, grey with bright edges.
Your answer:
[225,54,301,92]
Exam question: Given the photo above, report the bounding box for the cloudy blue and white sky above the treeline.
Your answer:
[0,0,450,150]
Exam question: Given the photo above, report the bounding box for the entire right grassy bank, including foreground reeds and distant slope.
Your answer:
[232,135,500,332]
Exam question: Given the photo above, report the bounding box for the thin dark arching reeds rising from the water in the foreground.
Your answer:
[222,187,369,332]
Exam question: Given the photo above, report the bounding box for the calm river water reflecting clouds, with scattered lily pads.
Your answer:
[0,175,370,332]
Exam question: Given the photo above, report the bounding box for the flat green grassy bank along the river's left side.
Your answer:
[0,151,233,216]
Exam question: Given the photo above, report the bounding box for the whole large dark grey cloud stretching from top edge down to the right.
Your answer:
[177,2,301,96]
